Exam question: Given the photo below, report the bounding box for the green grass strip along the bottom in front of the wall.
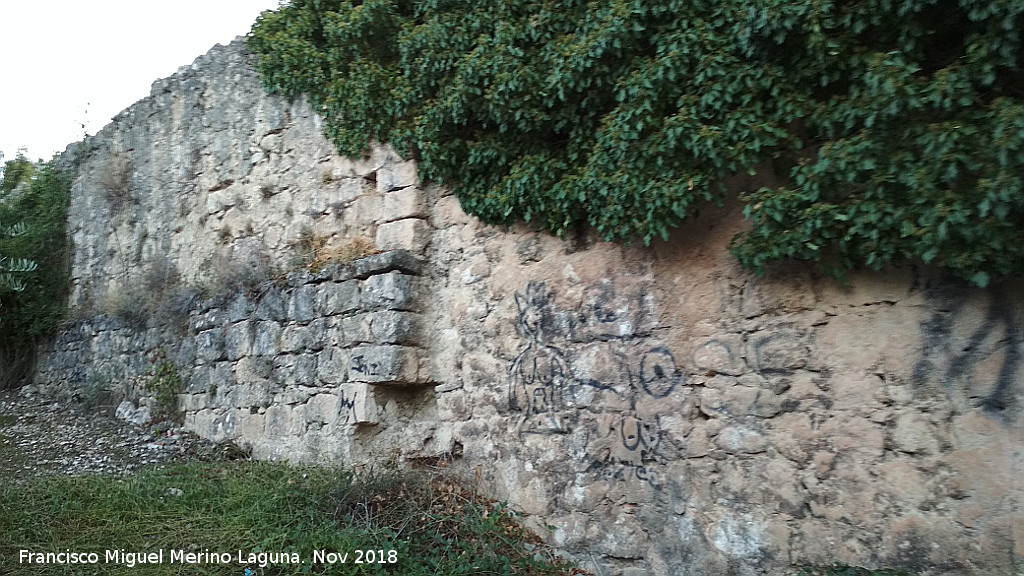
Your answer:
[0,461,572,576]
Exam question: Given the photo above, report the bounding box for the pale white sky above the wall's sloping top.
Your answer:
[0,0,279,161]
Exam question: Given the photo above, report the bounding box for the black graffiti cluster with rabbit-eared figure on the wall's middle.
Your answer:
[509,282,684,481]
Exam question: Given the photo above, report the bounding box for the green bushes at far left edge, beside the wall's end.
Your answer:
[0,156,72,387]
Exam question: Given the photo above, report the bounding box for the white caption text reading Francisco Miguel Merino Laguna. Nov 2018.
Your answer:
[17,549,398,568]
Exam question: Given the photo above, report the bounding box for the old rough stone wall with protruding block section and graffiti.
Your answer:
[37,42,1024,576]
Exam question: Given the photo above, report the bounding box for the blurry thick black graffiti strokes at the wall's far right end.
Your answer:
[913,286,1024,413]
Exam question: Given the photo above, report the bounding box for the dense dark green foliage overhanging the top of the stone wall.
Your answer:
[249,0,1024,285]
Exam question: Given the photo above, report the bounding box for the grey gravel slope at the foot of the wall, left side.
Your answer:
[0,390,247,482]
